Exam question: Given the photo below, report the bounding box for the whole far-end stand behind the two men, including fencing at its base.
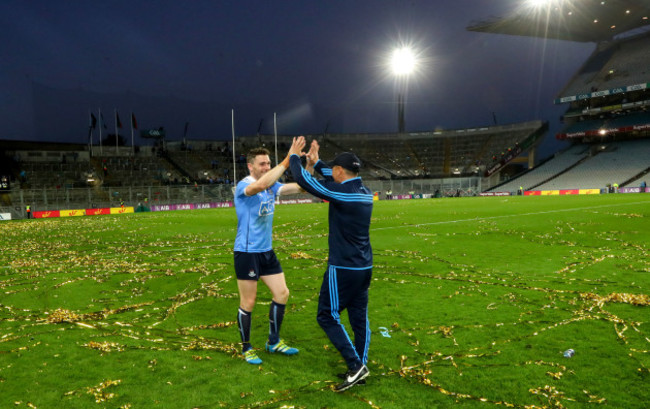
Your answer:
[0,115,546,214]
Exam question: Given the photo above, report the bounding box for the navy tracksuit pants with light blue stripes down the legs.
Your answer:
[317,265,372,369]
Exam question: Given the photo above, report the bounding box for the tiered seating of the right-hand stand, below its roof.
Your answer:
[484,25,650,192]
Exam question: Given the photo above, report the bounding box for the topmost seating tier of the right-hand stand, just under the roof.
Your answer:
[556,34,650,102]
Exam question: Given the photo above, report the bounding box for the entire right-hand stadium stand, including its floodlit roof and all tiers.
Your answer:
[467,0,650,192]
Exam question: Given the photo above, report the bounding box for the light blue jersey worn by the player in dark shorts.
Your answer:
[235,176,283,253]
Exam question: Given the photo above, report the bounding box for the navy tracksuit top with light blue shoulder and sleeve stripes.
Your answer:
[289,155,373,269]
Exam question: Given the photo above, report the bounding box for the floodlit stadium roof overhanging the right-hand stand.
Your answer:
[467,0,650,42]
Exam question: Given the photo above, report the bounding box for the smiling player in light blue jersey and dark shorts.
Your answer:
[234,141,313,365]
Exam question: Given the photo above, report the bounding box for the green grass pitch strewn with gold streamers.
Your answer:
[0,194,650,409]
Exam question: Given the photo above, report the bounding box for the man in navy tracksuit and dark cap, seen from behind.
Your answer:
[290,136,373,392]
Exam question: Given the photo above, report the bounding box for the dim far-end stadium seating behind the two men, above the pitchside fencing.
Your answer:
[1,121,547,195]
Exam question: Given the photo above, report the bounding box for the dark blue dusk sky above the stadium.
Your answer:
[0,0,594,158]
